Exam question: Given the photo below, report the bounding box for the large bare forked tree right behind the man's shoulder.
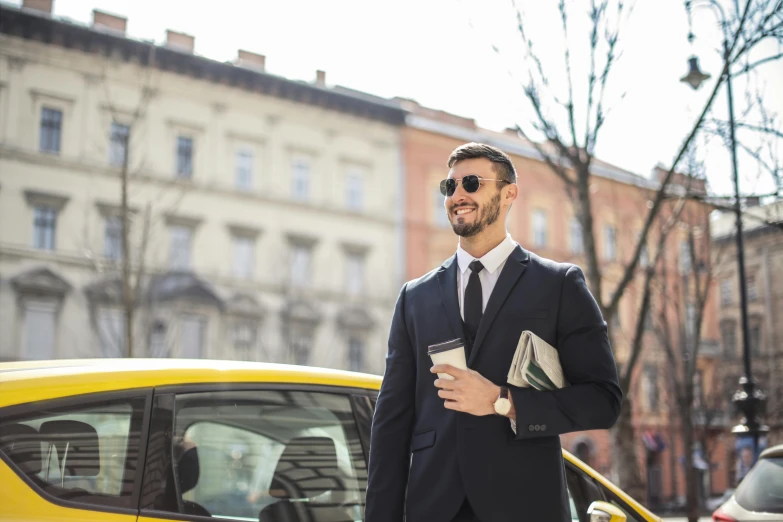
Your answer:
[472,0,783,497]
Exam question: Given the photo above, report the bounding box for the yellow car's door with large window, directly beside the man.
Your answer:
[139,385,369,522]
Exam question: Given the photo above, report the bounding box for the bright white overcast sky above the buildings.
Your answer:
[10,0,783,193]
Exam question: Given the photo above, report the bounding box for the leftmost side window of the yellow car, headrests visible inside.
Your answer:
[0,397,145,508]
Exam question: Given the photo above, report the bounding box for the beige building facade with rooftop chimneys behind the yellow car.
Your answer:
[0,2,405,373]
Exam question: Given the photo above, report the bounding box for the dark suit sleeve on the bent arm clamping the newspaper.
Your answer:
[510,266,622,439]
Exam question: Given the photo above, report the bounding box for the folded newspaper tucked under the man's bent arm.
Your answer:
[508,330,568,391]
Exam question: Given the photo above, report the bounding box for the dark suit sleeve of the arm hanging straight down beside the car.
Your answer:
[365,286,416,522]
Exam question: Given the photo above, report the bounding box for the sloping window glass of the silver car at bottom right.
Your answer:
[735,458,783,513]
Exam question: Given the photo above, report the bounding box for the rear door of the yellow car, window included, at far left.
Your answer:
[0,390,152,522]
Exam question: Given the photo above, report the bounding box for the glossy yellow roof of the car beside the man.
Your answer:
[0,359,381,408]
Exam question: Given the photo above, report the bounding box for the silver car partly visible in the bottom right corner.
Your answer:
[712,444,783,522]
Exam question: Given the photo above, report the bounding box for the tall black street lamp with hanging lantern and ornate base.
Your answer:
[680,0,769,470]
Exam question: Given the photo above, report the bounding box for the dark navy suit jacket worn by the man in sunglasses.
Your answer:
[366,247,622,522]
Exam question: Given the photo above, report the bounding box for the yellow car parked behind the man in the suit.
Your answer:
[0,359,661,522]
